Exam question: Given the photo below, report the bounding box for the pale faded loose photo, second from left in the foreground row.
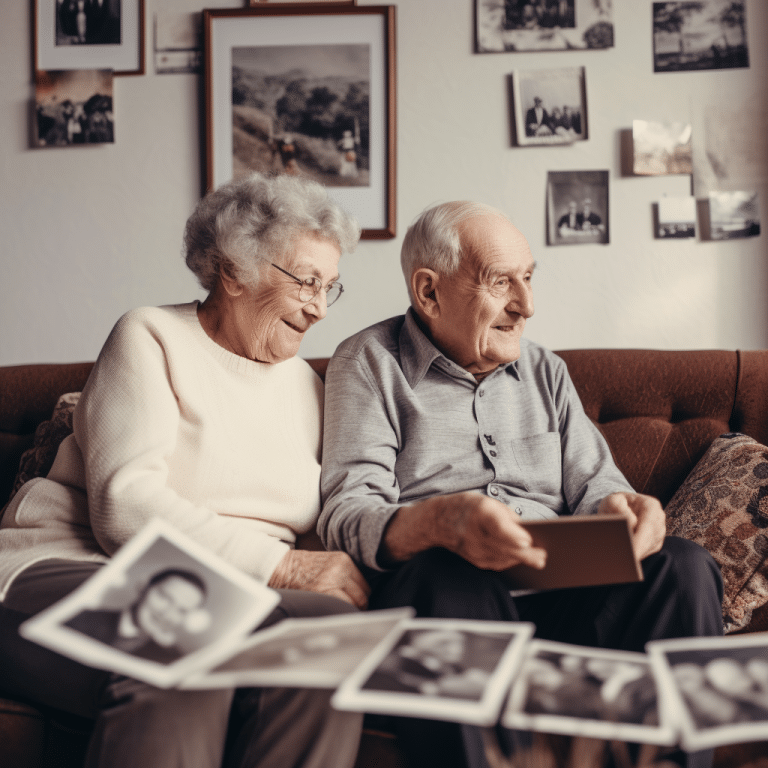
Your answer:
[179,608,414,689]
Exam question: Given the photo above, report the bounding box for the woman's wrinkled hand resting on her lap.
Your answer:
[267,549,371,609]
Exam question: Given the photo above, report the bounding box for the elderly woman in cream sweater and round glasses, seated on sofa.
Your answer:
[0,174,368,768]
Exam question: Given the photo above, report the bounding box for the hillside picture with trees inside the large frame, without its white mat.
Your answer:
[232,45,370,187]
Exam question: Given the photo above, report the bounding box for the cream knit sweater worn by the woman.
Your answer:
[0,302,323,600]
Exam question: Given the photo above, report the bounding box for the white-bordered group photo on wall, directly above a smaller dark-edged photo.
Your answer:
[512,67,587,146]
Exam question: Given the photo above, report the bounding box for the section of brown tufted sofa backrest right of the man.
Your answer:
[558,349,768,505]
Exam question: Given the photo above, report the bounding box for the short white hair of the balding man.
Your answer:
[400,200,507,303]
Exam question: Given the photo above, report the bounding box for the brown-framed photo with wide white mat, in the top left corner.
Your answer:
[33,0,145,75]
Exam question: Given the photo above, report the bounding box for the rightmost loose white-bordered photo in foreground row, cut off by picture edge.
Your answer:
[646,632,768,752]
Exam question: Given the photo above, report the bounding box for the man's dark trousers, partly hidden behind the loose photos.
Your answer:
[369,536,723,768]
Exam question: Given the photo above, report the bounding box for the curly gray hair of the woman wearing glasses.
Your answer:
[183,173,360,291]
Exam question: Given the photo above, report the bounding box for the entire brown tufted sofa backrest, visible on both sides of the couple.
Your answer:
[0,349,768,507]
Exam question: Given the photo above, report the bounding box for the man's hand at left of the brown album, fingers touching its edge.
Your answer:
[381,491,547,571]
